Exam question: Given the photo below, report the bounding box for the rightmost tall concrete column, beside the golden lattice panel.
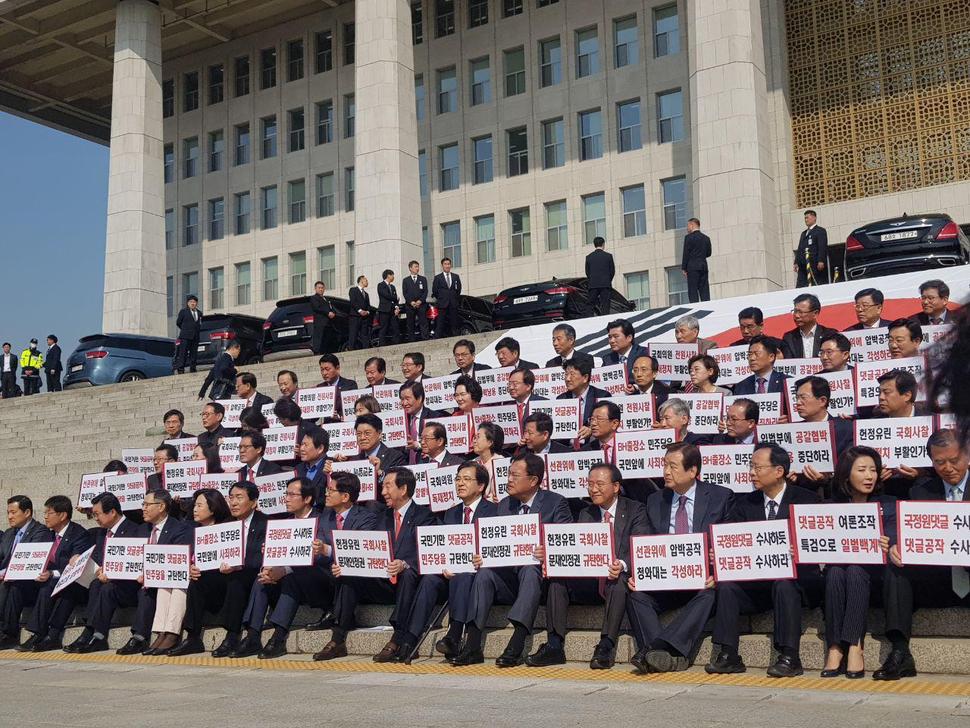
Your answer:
[687,0,791,298]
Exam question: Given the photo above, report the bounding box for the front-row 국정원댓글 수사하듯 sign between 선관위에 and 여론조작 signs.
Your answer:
[711,519,796,581]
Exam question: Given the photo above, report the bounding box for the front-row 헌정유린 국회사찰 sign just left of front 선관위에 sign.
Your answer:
[542,523,614,579]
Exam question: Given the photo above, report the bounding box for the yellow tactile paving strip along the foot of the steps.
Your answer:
[0,651,970,697]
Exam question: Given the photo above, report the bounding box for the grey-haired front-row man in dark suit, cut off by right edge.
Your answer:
[872,429,970,680]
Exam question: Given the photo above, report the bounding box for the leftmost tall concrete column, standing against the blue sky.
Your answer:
[102,0,167,336]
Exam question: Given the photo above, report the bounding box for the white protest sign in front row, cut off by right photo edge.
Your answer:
[896,500,970,566]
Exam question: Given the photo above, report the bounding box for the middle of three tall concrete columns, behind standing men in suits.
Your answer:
[354,0,427,282]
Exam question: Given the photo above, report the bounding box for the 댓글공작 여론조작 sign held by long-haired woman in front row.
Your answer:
[790,503,886,564]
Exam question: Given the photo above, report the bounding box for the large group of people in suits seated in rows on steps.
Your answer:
[0,281,970,680]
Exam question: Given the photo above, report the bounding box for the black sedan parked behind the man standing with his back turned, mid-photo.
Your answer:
[492,278,634,329]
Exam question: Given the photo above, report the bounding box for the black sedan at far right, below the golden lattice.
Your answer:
[845,213,970,281]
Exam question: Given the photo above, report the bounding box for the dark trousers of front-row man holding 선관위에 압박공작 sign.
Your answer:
[621,584,714,658]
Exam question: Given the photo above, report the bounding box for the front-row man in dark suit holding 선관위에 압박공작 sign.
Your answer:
[624,442,734,672]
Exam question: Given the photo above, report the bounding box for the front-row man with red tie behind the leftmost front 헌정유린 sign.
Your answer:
[314,467,436,662]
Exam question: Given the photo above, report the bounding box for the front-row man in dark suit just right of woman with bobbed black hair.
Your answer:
[168,481,268,657]
